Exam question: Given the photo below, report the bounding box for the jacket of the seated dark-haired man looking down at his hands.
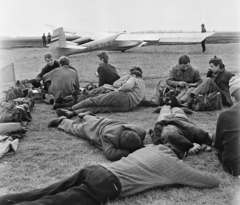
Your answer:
[166,64,202,88]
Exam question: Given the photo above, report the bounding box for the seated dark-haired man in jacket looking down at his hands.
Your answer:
[166,55,202,103]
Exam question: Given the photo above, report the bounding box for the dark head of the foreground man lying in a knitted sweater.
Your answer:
[163,134,193,159]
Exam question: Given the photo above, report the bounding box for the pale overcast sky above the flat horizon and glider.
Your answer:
[0,0,240,36]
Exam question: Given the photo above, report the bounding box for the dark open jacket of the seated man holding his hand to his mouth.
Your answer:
[207,68,234,106]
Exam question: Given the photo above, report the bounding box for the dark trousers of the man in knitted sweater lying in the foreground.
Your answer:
[0,165,121,205]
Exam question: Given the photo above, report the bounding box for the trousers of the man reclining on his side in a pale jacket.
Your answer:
[72,91,131,114]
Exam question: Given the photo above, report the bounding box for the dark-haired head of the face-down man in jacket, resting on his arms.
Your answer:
[120,130,142,152]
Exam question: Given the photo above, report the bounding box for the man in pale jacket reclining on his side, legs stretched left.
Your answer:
[56,70,146,118]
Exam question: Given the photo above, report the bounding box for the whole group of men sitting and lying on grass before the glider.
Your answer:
[0,52,240,205]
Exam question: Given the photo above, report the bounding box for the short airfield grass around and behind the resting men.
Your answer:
[0,43,240,205]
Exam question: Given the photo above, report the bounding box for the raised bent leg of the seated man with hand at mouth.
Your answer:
[192,78,219,95]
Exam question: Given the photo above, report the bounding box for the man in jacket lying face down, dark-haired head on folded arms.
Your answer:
[49,112,146,161]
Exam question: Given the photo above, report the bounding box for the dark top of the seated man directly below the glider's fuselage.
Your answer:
[97,63,120,87]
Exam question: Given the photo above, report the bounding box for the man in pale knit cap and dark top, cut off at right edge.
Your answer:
[213,76,240,176]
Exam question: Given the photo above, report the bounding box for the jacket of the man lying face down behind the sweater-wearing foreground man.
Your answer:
[82,115,146,161]
